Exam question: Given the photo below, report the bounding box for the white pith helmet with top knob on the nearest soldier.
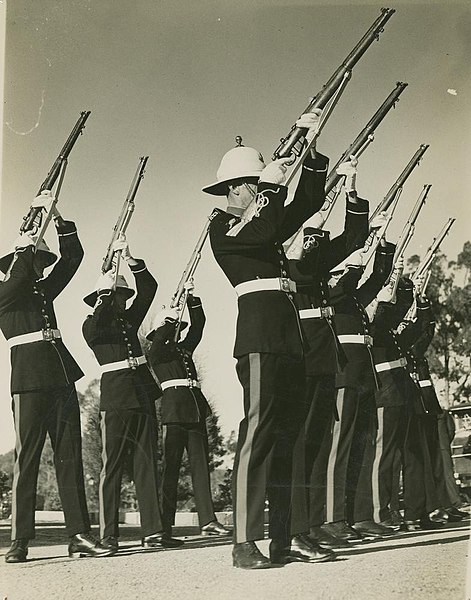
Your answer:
[203,136,265,196]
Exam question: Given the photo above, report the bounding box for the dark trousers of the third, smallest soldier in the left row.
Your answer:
[162,422,216,530]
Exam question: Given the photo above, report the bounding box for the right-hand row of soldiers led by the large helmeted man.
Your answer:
[204,110,467,569]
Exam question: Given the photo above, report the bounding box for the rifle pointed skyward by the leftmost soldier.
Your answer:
[20,110,90,239]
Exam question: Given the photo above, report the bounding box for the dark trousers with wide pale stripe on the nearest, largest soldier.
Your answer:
[232,353,305,544]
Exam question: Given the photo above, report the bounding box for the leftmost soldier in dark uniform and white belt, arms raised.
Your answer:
[0,191,109,563]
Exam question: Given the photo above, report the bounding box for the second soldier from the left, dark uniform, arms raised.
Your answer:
[83,234,183,553]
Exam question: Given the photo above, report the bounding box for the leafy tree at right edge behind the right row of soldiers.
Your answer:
[408,242,471,407]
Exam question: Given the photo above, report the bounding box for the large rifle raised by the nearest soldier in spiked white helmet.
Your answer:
[273,8,395,170]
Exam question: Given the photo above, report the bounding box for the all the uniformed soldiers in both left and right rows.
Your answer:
[0,110,463,569]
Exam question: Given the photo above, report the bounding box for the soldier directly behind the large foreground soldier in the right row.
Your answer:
[288,157,376,560]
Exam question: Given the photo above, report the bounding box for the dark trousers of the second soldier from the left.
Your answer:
[99,408,162,538]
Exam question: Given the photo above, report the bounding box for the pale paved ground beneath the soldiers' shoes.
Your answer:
[0,522,471,600]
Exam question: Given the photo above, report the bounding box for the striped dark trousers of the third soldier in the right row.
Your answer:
[324,387,374,523]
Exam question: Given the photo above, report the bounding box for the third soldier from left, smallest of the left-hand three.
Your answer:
[147,282,231,535]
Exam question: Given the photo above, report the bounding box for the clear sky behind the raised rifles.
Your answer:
[0,0,471,452]
